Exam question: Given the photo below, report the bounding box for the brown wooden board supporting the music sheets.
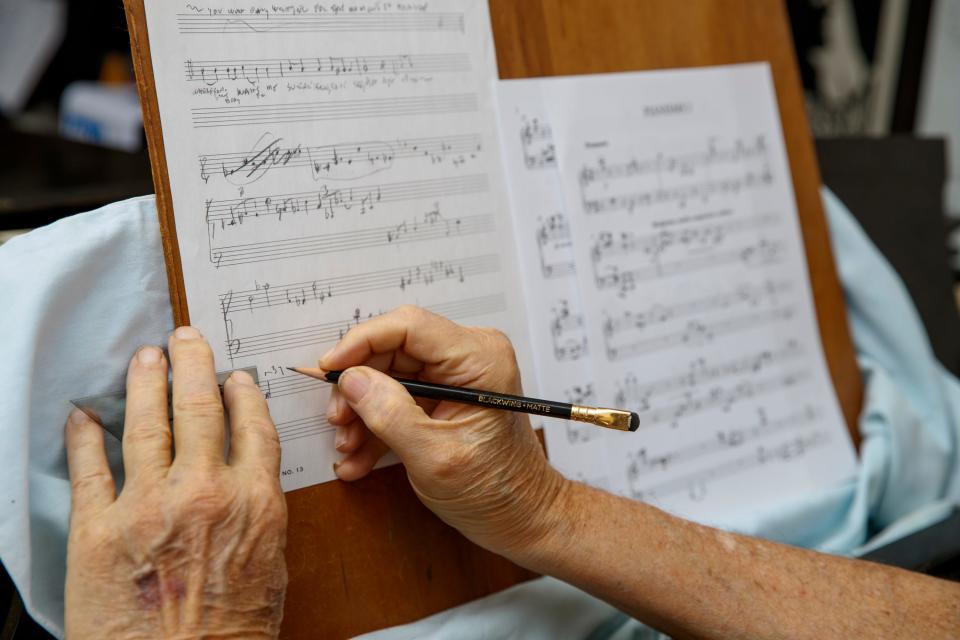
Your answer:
[124,0,862,638]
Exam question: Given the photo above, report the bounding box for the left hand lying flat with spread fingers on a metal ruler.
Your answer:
[66,327,287,639]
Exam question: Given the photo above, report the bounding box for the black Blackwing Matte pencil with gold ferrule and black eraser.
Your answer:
[287,367,640,431]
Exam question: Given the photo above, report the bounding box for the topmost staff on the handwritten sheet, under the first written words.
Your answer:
[177,12,464,35]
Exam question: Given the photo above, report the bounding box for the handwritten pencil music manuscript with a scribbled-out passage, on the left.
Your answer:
[145,0,525,490]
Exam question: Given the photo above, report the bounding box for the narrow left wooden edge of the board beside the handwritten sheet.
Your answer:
[123,0,190,327]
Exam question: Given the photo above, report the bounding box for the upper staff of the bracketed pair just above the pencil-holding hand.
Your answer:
[219,254,500,318]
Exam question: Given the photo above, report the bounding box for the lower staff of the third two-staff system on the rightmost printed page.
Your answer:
[606,307,794,362]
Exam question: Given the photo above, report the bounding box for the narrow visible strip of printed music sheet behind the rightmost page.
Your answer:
[499,87,610,488]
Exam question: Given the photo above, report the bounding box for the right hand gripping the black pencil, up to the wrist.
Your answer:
[319,306,565,562]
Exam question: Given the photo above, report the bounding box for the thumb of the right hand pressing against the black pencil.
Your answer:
[337,367,430,458]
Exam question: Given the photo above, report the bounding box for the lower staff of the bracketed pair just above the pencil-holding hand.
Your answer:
[225,294,506,363]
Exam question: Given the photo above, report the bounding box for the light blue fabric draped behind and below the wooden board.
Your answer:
[0,192,960,640]
